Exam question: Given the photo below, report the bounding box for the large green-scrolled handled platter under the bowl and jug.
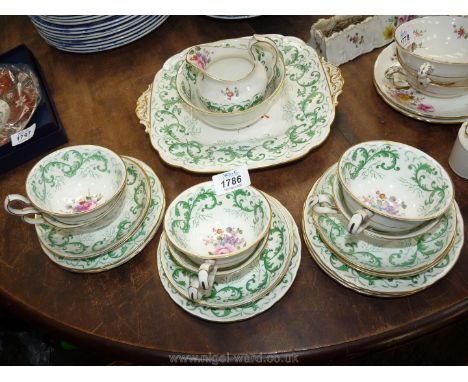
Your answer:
[136,35,343,173]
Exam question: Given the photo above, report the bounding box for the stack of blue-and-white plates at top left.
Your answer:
[30,16,168,53]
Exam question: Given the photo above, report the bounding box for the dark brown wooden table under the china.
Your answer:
[0,16,468,363]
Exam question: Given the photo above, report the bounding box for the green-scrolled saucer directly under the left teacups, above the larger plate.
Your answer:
[36,158,151,259]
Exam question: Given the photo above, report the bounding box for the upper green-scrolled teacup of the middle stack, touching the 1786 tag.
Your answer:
[164,182,271,290]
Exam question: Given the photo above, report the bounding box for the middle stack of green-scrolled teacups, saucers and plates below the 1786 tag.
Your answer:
[158,182,301,322]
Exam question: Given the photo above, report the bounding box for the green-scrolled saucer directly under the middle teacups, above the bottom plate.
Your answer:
[158,195,294,308]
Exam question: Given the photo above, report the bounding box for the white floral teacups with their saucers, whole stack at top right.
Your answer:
[374,16,468,124]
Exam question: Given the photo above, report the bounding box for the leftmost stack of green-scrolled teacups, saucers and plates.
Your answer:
[5,145,165,273]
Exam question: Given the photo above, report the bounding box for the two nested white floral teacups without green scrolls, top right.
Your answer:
[386,16,468,98]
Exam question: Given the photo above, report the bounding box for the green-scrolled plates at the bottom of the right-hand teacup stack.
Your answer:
[302,178,464,297]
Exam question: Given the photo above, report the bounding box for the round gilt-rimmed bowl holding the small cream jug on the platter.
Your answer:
[176,35,286,130]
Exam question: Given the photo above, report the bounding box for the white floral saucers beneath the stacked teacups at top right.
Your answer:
[374,43,468,124]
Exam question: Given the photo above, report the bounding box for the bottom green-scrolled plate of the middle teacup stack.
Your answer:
[158,194,301,323]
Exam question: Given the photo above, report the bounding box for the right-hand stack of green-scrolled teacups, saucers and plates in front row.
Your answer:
[303,141,464,297]
